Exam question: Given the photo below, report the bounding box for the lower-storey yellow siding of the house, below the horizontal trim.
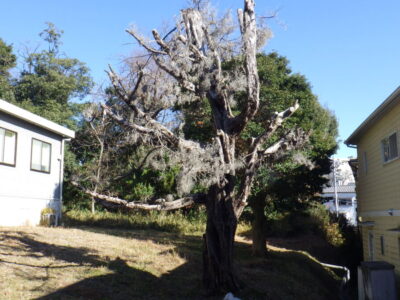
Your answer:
[361,217,400,275]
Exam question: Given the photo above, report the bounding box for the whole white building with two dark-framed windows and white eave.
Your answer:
[0,100,75,226]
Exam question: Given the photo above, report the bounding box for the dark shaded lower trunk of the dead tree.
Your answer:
[203,178,240,293]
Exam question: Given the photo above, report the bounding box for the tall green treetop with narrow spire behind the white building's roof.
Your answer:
[14,23,93,129]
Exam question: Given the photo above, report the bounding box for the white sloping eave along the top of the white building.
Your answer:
[0,99,75,138]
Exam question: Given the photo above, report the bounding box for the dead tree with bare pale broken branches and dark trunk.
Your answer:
[79,0,307,291]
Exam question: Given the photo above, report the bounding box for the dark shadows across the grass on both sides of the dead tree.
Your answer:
[0,227,337,300]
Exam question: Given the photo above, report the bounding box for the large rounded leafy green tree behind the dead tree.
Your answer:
[183,52,337,253]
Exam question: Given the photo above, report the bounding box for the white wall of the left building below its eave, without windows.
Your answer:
[0,112,62,226]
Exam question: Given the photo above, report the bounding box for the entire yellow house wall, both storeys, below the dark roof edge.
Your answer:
[356,99,400,274]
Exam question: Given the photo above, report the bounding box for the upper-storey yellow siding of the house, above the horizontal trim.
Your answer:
[357,100,400,213]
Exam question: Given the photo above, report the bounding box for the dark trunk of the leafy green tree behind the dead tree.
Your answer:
[249,195,267,256]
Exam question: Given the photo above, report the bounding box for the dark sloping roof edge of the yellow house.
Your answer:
[344,86,400,146]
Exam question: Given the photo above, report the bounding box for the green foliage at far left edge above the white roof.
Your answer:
[0,39,17,101]
